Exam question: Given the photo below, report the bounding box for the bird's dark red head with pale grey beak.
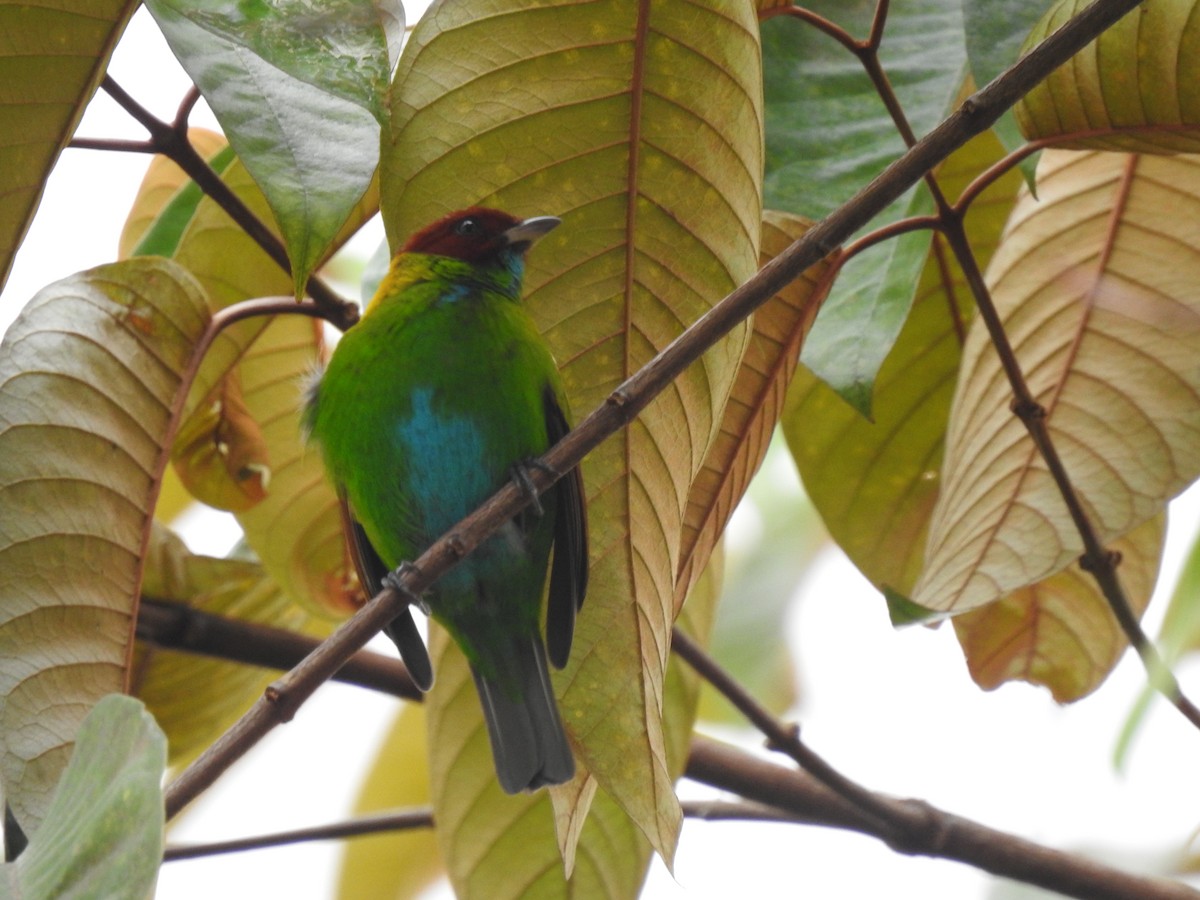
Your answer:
[402,206,560,265]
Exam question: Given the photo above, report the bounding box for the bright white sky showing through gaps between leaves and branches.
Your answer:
[0,11,1200,900]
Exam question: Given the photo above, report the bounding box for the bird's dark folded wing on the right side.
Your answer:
[542,385,588,668]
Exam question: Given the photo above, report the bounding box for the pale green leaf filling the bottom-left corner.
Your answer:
[0,695,167,900]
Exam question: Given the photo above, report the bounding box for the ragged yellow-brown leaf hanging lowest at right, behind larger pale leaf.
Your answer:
[954,516,1166,703]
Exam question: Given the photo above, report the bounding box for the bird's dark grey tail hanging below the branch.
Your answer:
[472,635,575,793]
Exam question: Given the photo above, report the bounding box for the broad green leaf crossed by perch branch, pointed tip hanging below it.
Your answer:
[763,0,966,415]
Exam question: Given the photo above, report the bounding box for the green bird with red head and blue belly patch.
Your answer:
[304,206,588,794]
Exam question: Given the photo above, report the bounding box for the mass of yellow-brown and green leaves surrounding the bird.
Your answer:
[0,0,1200,898]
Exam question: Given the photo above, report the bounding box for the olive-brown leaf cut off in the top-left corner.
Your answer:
[0,0,138,288]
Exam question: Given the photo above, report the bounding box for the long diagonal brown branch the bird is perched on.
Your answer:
[167,0,1139,816]
